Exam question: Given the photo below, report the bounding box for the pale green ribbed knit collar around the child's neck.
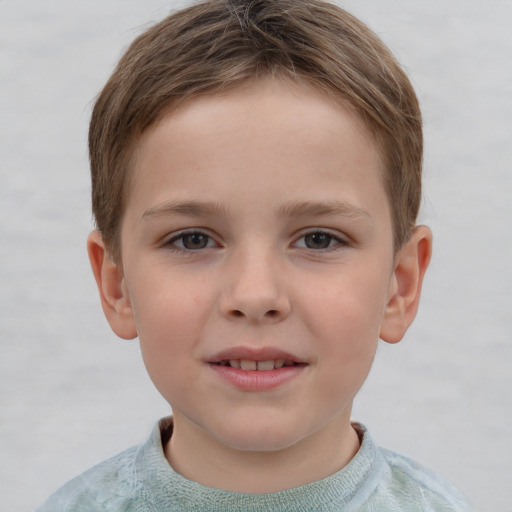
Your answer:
[133,417,382,512]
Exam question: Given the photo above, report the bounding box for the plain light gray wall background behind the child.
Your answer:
[0,0,512,512]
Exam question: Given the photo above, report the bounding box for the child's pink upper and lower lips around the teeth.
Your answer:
[208,347,308,392]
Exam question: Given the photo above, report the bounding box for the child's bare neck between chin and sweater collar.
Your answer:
[165,416,360,494]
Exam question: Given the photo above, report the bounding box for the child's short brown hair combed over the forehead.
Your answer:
[89,0,423,258]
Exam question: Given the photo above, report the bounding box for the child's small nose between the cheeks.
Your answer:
[220,251,291,324]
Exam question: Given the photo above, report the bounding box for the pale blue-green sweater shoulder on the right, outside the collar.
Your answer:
[379,448,473,512]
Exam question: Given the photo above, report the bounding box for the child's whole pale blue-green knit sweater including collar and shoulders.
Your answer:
[36,418,472,512]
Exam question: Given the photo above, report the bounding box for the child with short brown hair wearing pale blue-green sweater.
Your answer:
[39,0,469,512]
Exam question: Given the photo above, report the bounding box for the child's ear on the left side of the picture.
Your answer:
[87,231,137,340]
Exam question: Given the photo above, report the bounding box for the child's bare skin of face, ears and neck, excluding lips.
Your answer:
[88,78,432,493]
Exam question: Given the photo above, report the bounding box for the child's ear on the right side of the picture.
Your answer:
[380,226,432,343]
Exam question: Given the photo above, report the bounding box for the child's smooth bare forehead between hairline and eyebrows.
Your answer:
[128,78,388,220]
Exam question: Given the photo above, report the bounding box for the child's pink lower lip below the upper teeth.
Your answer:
[210,364,306,391]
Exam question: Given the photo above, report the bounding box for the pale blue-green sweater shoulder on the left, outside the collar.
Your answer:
[36,447,138,512]
